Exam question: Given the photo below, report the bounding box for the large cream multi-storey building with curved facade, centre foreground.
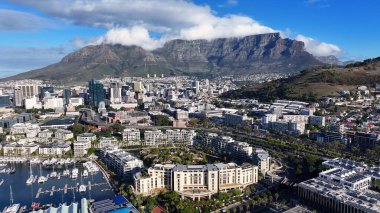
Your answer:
[134,163,258,200]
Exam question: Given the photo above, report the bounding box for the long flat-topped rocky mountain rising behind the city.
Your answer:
[5,33,322,81]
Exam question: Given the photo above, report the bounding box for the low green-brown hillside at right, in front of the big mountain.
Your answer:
[221,57,380,101]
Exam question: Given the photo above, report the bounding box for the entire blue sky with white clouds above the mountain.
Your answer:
[0,0,380,78]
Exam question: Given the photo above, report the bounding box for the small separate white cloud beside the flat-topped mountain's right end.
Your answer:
[295,35,343,56]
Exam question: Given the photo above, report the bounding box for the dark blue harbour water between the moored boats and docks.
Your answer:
[0,163,115,212]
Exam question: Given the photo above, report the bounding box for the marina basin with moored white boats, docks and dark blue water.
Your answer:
[0,159,115,208]
